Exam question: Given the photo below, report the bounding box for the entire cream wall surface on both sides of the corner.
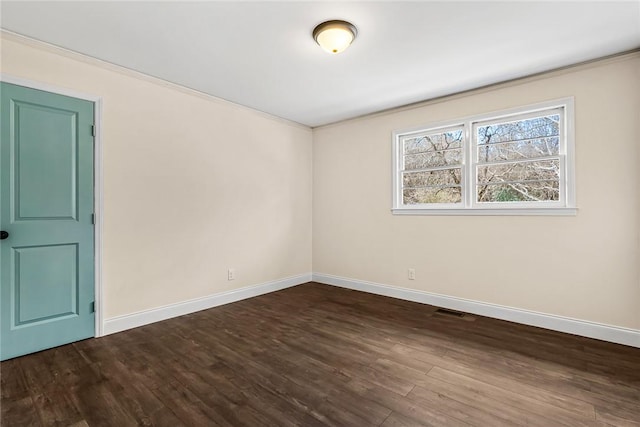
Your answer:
[1,33,640,336]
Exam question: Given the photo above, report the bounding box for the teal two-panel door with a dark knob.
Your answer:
[0,82,95,360]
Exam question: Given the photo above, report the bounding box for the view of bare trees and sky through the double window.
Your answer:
[396,107,565,207]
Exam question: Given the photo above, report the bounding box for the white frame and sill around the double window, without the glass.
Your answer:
[391,97,577,215]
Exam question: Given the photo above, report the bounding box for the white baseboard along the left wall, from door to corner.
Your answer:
[102,273,311,336]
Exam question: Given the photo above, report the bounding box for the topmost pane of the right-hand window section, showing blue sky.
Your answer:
[476,114,560,144]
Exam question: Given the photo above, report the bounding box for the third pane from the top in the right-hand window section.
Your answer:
[478,159,560,184]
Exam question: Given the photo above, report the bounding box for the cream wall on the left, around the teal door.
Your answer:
[2,33,312,319]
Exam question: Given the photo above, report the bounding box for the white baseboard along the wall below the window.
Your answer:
[313,273,640,348]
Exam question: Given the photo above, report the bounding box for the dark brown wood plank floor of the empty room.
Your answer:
[0,283,640,427]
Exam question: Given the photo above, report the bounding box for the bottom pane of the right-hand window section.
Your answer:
[478,181,560,202]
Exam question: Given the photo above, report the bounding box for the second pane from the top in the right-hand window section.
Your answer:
[478,136,560,163]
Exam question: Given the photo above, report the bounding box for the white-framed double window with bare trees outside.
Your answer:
[393,98,576,215]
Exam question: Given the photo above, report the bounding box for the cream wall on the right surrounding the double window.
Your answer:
[313,54,640,329]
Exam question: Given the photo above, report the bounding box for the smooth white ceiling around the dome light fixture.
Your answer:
[0,0,640,126]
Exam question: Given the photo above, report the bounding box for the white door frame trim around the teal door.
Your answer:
[0,73,104,337]
